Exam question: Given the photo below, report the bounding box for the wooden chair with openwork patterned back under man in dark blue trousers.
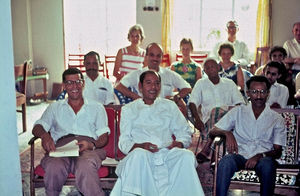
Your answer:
[213,109,300,195]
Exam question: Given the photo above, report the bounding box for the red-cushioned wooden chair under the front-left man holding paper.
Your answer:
[28,105,121,196]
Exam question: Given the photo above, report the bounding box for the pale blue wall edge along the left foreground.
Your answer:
[0,0,22,196]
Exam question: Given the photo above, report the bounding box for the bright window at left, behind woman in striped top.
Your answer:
[63,0,136,62]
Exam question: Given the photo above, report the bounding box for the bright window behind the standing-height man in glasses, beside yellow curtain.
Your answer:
[171,0,258,56]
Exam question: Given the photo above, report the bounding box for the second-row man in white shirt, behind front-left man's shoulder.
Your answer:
[83,51,115,105]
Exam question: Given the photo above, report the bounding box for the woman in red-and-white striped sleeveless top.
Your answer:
[113,24,146,81]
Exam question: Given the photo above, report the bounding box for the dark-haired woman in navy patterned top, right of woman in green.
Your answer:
[218,44,245,92]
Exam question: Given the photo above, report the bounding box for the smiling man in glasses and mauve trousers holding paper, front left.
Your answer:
[32,68,110,196]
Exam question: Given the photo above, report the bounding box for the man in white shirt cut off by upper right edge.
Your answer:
[283,22,300,78]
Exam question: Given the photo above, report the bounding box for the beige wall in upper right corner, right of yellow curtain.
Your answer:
[272,0,300,46]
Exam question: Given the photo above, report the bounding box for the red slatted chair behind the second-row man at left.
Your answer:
[68,54,109,78]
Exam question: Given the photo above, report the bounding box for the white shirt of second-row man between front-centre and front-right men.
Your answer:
[189,77,244,123]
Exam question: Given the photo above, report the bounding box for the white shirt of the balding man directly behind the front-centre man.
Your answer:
[120,67,191,97]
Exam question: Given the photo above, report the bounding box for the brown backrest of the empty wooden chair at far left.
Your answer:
[14,61,31,96]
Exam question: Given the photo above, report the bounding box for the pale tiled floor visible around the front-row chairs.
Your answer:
[17,102,259,196]
